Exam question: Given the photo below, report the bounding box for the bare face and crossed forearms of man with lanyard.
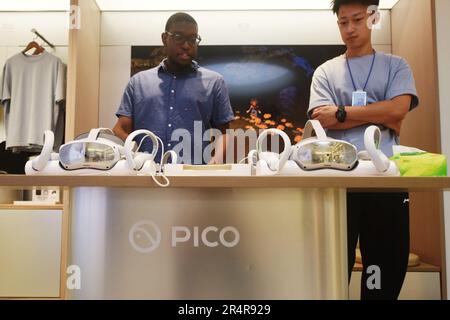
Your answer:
[311,4,412,136]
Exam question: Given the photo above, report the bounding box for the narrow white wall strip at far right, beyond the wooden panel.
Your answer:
[436,0,450,297]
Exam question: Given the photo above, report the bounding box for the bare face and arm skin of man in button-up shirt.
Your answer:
[113,22,230,163]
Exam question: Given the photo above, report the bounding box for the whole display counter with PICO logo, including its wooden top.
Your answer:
[0,176,450,299]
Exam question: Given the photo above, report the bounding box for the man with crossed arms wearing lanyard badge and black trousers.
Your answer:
[308,0,419,299]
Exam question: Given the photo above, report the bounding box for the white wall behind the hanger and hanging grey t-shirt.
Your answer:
[0,12,69,142]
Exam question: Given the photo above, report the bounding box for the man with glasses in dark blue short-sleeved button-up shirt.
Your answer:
[114,12,234,164]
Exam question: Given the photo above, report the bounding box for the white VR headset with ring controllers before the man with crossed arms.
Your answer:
[248,120,399,176]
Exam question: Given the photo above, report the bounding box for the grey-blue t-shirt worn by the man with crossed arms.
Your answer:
[308,52,419,156]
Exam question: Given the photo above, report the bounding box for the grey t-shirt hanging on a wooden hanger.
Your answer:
[0,51,66,148]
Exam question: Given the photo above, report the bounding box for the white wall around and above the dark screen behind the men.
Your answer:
[99,10,391,127]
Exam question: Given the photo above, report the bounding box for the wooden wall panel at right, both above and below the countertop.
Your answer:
[391,0,445,298]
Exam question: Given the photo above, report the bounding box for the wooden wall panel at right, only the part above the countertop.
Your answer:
[391,0,441,152]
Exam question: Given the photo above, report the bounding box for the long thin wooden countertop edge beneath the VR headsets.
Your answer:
[0,175,450,191]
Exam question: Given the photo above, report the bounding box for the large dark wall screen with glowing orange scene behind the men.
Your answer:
[131,45,345,142]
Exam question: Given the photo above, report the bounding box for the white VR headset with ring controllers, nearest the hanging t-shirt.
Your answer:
[25,128,169,187]
